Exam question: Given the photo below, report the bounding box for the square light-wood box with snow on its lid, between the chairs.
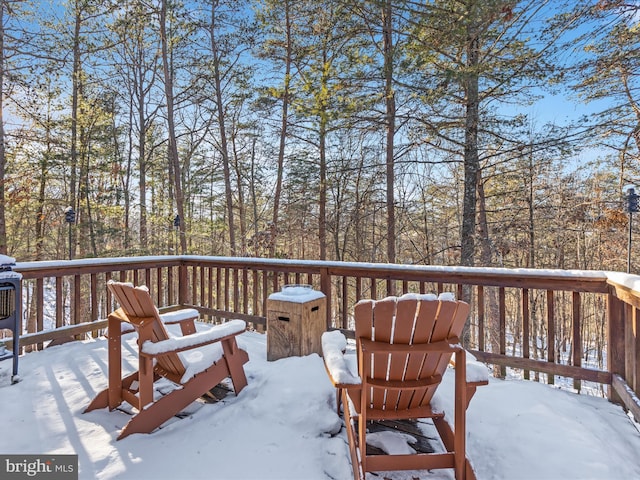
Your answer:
[267,285,327,361]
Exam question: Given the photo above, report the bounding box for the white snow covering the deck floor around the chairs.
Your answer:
[0,326,640,480]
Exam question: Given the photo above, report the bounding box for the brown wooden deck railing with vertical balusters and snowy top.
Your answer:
[5,256,640,419]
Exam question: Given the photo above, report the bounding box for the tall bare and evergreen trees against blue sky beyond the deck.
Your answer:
[0,0,640,271]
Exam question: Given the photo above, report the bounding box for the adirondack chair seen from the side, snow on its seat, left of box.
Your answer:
[85,281,249,440]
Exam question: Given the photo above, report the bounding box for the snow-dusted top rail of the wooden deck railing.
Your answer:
[15,255,624,293]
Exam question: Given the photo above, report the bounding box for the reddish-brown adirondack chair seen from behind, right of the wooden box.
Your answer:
[323,295,488,480]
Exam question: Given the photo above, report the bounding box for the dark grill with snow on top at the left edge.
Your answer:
[0,265,22,383]
